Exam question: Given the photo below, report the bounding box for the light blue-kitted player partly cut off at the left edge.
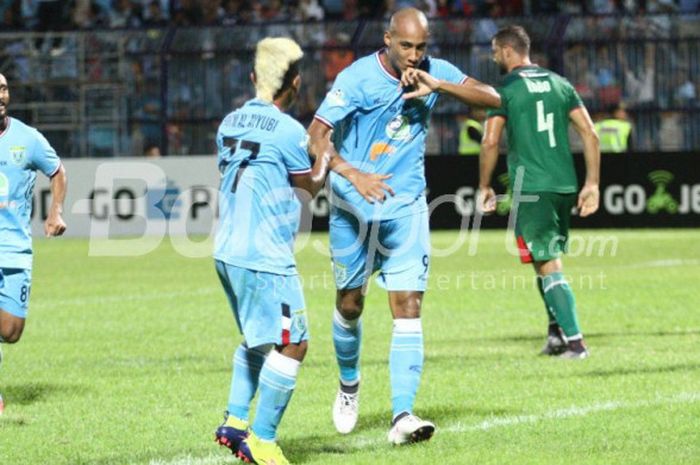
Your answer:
[0,74,66,413]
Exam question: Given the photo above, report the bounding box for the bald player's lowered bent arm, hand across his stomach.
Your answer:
[308,119,394,203]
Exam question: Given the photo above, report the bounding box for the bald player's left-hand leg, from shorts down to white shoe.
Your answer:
[330,210,372,434]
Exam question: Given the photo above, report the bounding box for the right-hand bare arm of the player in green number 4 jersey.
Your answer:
[569,105,600,216]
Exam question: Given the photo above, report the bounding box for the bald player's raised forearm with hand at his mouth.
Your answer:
[401,68,501,108]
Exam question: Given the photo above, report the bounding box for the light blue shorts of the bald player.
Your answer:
[330,207,430,291]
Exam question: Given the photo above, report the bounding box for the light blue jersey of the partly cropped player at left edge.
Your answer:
[0,117,61,270]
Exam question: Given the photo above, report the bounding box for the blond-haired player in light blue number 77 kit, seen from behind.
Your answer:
[214,38,348,465]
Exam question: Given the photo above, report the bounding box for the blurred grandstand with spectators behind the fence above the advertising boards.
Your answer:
[0,0,700,157]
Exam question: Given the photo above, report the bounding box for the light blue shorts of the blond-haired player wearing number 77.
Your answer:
[216,260,309,348]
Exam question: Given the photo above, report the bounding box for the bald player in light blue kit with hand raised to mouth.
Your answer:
[309,8,500,444]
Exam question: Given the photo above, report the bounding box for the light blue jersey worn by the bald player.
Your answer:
[315,50,467,222]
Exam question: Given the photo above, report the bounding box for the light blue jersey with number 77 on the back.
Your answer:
[214,99,311,275]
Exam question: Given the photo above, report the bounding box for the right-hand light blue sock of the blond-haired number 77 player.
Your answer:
[252,350,301,441]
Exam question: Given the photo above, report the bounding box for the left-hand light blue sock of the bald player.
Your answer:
[333,309,362,385]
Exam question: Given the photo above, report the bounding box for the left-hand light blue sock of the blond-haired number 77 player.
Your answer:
[228,342,267,421]
